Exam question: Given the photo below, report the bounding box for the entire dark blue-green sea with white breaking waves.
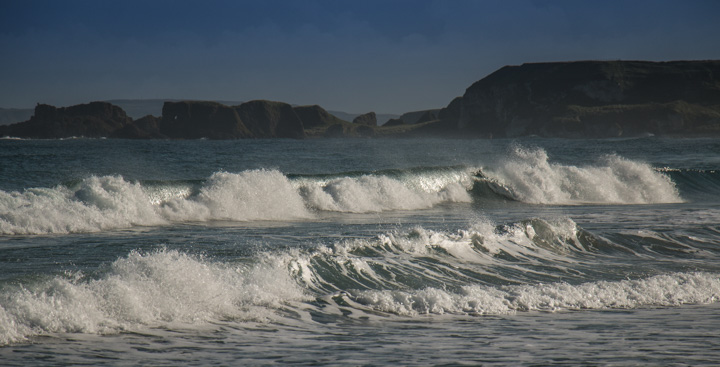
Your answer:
[0,137,720,366]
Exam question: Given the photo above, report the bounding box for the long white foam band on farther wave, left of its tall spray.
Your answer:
[0,169,471,234]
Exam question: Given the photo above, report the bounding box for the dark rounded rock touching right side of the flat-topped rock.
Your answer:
[233,100,305,139]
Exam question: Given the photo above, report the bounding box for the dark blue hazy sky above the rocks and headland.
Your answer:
[0,0,720,113]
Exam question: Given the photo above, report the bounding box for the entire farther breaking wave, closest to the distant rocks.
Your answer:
[0,147,696,234]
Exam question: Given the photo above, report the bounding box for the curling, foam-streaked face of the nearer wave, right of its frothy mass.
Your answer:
[289,218,601,293]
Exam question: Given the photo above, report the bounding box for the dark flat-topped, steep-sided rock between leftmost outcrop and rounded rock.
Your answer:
[159,101,253,139]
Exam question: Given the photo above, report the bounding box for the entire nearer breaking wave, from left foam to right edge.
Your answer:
[0,219,720,345]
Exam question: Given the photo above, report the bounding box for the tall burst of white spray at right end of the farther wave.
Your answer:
[485,147,682,204]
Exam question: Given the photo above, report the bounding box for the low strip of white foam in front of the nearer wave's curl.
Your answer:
[352,273,720,316]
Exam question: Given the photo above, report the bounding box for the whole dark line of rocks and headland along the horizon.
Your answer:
[0,61,720,139]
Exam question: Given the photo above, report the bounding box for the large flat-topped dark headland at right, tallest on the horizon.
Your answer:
[450,61,720,137]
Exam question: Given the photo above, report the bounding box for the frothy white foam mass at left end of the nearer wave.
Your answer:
[0,250,307,345]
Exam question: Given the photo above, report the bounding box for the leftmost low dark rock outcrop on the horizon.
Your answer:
[0,102,132,139]
